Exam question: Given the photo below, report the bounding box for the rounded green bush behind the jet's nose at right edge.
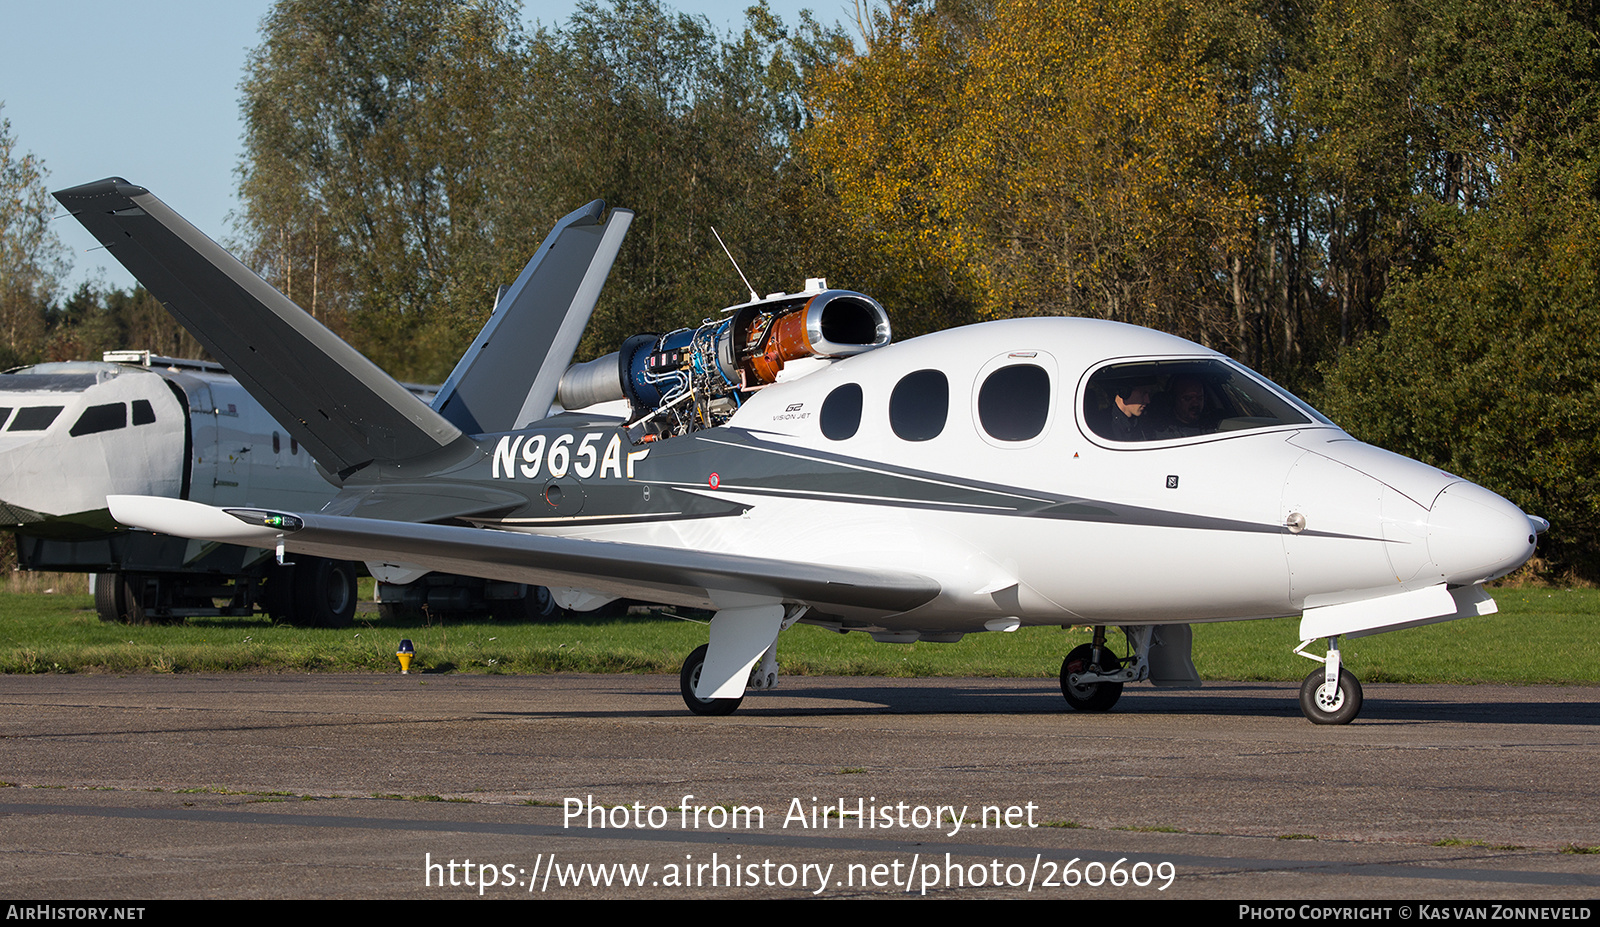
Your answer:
[1323,183,1600,576]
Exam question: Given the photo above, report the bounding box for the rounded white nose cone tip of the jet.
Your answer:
[1427,482,1534,584]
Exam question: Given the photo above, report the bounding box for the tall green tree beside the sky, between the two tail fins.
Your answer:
[240,0,520,378]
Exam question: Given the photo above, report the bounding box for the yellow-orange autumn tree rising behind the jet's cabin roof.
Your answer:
[803,0,1253,343]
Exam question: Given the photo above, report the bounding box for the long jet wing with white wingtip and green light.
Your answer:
[107,496,939,621]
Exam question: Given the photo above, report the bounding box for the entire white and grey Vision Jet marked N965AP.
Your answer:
[56,178,1547,724]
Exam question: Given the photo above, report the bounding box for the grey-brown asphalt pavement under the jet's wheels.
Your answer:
[0,674,1600,903]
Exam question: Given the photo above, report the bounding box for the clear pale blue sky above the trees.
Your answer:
[0,0,846,288]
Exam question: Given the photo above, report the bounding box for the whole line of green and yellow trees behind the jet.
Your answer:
[0,0,1600,576]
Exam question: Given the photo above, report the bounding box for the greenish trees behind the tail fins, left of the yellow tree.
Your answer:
[238,0,838,379]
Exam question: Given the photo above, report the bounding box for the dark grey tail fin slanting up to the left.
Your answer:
[54,178,462,482]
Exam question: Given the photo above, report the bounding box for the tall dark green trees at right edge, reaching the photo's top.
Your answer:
[1323,2,1600,576]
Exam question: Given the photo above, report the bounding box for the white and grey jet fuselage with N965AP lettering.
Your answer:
[353,319,1534,639]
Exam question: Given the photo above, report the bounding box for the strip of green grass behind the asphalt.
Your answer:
[0,589,1600,684]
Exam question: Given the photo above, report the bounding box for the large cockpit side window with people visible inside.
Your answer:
[1083,359,1331,442]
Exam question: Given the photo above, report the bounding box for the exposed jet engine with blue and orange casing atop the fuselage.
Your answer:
[557,279,891,442]
